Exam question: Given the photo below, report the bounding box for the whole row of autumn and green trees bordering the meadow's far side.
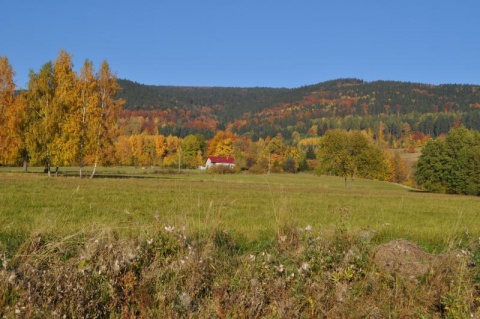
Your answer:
[0,50,480,195]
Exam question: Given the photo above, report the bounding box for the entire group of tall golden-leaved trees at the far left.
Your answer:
[0,50,124,176]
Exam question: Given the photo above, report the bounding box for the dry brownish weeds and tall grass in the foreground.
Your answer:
[0,218,480,318]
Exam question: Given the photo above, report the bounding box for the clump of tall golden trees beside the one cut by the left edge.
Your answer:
[20,50,123,177]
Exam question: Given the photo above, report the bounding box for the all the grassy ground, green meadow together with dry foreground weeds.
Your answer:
[0,167,480,318]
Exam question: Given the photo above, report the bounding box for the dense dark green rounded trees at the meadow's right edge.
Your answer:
[415,127,480,195]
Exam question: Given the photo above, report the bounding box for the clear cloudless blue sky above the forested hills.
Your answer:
[0,0,480,88]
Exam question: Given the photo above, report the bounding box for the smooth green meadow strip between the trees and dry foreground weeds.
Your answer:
[0,168,480,252]
